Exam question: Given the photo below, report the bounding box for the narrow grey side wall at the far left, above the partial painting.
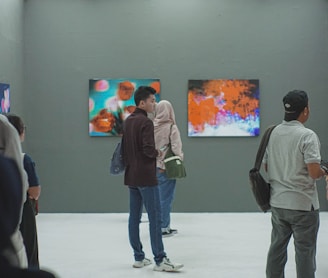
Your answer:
[0,0,23,114]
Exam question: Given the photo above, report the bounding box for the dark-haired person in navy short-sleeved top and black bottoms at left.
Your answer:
[6,114,41,269]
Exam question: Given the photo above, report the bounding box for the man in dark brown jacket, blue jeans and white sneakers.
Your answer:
[123,86,183,271]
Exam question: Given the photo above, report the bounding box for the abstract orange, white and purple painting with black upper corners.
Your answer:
[188,79,260,137]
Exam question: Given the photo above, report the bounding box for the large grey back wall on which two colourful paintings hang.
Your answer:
[23,0,328,212]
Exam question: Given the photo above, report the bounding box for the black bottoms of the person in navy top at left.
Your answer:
[20,197,40,269]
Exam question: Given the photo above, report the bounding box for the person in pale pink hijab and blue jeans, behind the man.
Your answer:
[153,100,183,237]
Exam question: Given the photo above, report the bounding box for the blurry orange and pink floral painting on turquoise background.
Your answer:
[89,79,161,136]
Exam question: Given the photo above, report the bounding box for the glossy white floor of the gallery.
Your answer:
[37,212,328,278]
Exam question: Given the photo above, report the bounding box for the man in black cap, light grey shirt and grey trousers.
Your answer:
[263,90,326,278]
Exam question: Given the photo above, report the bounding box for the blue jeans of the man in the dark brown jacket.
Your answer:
[129,186,166,264]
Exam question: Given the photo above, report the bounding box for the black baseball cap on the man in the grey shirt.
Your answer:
[282,90,309,115]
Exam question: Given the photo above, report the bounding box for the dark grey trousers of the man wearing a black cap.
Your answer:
[266,208,319,278]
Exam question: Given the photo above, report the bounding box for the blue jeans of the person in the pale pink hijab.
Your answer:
[157,169,176,232]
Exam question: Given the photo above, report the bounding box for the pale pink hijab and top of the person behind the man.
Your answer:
[153,100,183,169]
